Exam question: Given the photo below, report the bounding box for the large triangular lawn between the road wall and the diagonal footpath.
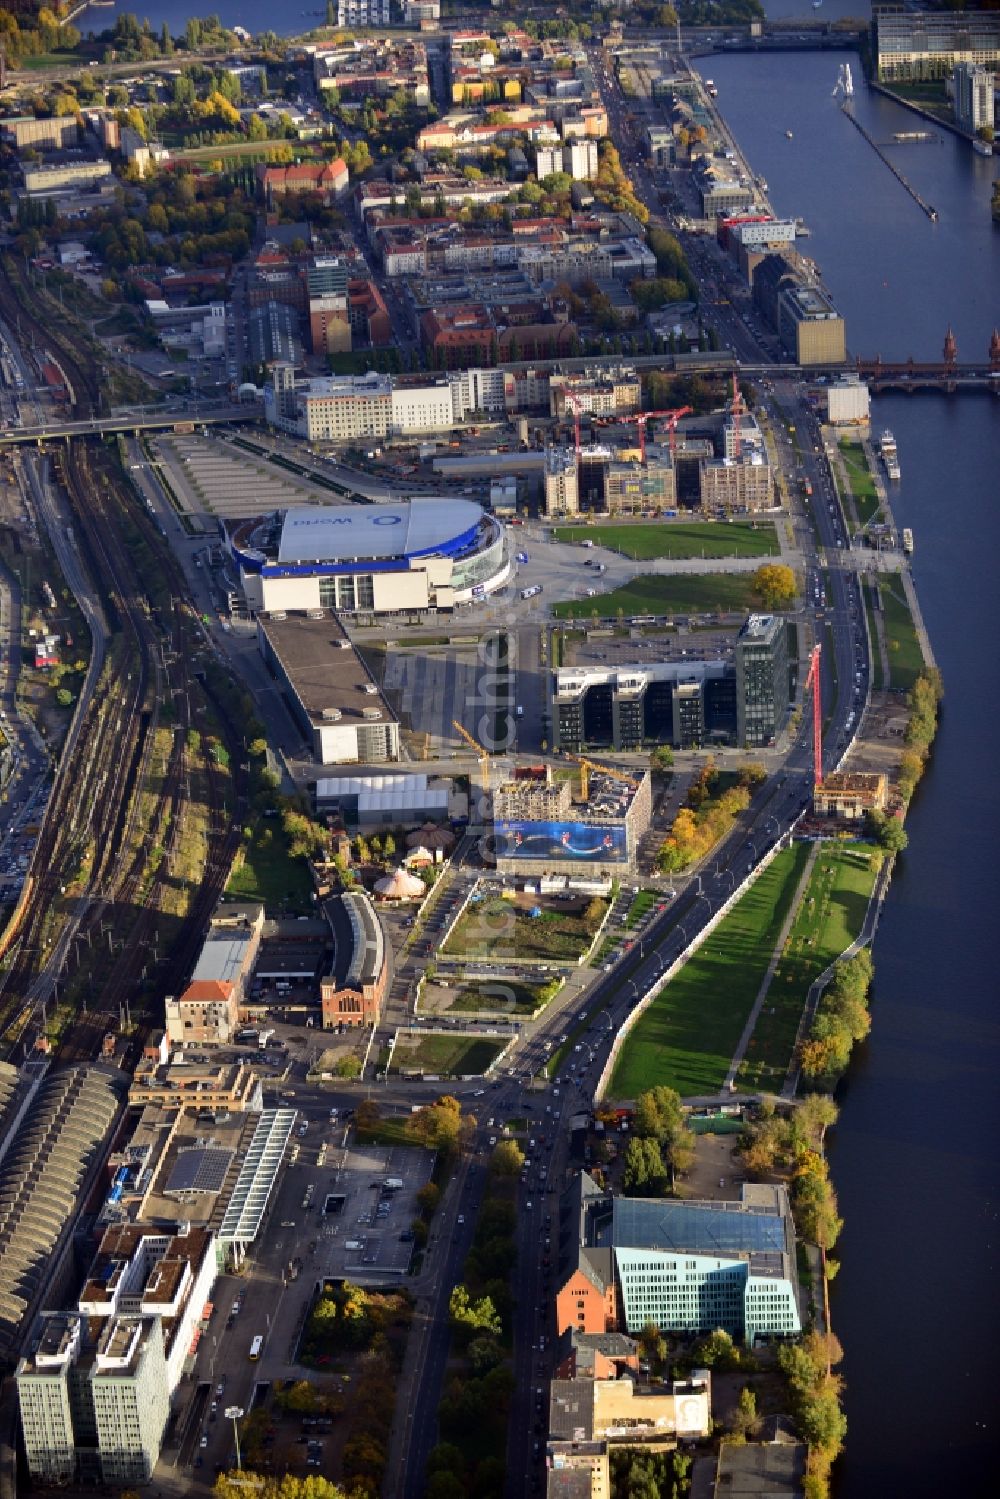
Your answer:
[609,842,808,1099]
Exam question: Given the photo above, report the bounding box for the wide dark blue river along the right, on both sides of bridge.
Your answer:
[702,41,1000,1499]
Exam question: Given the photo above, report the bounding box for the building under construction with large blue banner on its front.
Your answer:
[493,761,652,875]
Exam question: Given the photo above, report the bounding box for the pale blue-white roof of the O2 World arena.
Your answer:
[277,497,483,562]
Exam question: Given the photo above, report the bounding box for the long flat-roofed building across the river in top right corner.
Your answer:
[871,3,1000,82]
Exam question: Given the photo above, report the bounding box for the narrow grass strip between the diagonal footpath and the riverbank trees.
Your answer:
[736,842,876,1091]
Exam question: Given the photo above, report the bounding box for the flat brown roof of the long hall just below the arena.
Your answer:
[258,609,394,726]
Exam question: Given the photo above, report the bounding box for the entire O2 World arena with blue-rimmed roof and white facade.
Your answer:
[226,498,513,615]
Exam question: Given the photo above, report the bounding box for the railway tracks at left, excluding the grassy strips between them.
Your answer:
[0,266,246,1061]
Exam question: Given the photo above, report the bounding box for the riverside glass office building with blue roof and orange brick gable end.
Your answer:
[556,1172,802,1346]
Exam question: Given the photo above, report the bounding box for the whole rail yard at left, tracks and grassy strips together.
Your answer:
[0,254,246,1061]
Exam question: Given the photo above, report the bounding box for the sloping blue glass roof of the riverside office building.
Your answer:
[612,1198,786,1255]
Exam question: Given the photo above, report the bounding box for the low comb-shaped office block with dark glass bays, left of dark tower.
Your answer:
[550,655,736,754]
